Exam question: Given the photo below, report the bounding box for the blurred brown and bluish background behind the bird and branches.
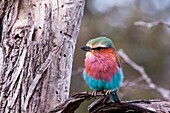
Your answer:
[70,0,170,113]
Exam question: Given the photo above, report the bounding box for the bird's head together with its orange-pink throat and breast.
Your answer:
[81,37,118,80]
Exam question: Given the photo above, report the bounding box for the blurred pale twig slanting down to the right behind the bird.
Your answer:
[118,49,170,101]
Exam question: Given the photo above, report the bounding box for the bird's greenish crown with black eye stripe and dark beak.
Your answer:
[81,37,115,52]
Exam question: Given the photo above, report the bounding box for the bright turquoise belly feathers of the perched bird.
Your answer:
[83,68,123,91]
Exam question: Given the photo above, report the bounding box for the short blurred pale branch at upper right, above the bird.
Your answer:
[134,20,170,29]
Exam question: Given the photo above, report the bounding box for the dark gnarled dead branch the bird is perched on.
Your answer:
[49,92,170,113]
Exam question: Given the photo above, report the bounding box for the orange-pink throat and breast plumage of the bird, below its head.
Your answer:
[85,51,118,81]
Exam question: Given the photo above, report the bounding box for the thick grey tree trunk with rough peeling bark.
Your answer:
[0,0,85,113]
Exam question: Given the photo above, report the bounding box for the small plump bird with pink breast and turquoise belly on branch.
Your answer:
[81,37,124,103]
